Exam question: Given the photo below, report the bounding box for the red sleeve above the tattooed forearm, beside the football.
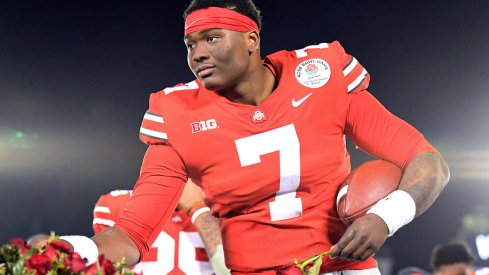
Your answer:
[345,90,436,169]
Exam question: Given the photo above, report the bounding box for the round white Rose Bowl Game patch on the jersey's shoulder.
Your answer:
[295,58,331,88]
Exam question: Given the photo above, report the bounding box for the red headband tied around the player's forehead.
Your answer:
[184,7,258,35]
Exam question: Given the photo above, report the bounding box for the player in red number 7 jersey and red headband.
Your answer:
[30,0,449,275]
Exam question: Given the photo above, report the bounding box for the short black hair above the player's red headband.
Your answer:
[183,0,261,29]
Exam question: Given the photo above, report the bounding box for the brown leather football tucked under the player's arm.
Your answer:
[336,160,402,226]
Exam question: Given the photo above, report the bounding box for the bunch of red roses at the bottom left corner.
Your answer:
[0,233,134,275]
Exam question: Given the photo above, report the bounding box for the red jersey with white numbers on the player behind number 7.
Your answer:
[93,190,214,275]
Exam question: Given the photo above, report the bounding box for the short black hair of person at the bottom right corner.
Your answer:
[431,243,475,269]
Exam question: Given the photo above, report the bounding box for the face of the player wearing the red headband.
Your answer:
[185,29,250,91]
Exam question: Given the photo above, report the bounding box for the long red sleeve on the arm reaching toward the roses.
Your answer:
[115,145,187,258]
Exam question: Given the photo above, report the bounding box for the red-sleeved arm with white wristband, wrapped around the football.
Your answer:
[331,91,450,261]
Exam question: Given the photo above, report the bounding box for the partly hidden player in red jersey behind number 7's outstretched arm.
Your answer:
[93,181,229,275]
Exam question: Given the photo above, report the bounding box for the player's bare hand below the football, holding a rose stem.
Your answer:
[331,214,389,261]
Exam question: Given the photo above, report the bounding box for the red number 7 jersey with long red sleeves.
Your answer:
[117,42,433,272]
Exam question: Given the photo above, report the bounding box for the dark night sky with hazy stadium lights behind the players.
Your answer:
[0,0,489,271]
